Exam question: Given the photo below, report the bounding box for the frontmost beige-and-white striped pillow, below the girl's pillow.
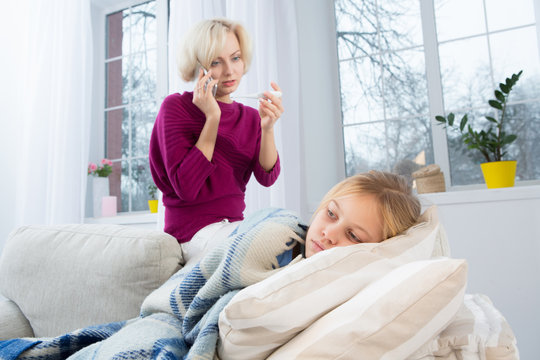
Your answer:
[268,258,467,360]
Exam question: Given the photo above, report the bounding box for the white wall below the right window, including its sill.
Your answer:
[422,186,540,359]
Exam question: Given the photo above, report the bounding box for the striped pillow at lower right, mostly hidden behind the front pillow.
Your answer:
[409,294,519,360]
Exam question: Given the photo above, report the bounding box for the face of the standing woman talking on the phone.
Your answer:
[208,31,244,102]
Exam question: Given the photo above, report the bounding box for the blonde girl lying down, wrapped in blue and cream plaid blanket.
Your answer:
[0,171,421,359]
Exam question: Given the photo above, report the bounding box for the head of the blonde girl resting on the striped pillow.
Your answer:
[280,170,421,265]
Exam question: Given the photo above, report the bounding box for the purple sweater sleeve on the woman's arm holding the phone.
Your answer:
[156,97,215,201]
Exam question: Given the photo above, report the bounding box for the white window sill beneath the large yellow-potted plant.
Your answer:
[418,185,540,205]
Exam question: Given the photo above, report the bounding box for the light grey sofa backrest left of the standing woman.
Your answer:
[0,224,183,337]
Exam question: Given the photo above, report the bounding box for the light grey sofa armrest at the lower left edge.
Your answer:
[0,296,34,341]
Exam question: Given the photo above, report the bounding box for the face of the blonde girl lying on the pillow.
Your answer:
[306,194,384,257]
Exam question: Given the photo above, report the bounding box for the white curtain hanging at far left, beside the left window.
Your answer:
[0,0,92,250]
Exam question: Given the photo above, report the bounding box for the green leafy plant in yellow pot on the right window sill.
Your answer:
[435,71,523,189]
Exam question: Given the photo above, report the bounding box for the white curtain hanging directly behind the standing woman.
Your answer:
[162,0,301,222]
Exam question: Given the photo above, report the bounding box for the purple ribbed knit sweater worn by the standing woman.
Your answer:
[150,92,280,243]
